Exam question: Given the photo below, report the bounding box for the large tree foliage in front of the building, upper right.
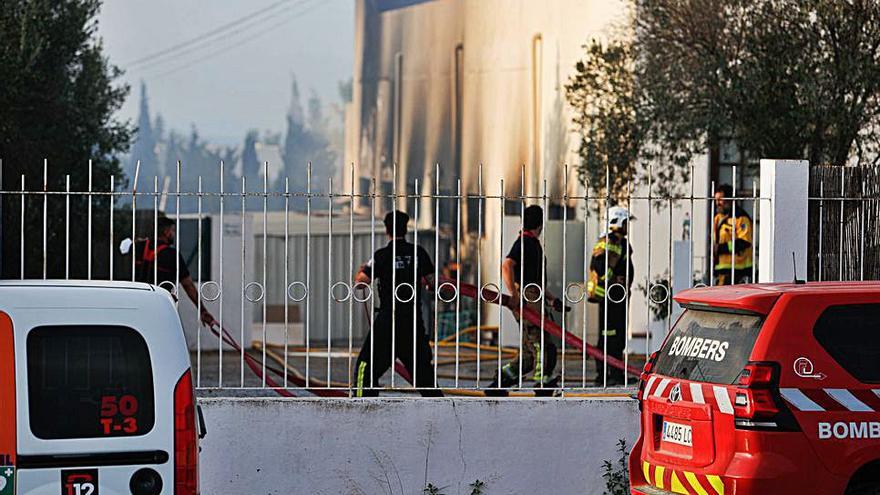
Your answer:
[568,0,880,198]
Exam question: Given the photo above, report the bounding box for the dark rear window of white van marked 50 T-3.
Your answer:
[27,326,155,439]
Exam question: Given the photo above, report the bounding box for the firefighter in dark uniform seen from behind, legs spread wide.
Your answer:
[353,211,443,397]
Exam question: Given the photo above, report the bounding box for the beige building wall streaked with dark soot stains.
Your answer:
[346,0,710,349]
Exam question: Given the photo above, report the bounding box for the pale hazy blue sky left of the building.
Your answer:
[98,0,354,144]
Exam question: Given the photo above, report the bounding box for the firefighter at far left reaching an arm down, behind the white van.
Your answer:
[134,216,217,327]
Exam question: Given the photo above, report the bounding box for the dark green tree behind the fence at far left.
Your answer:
[0,0,132,277]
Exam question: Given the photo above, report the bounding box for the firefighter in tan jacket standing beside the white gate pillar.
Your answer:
[712,184,753,285]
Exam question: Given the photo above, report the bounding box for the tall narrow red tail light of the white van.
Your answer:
[174,370,199,495]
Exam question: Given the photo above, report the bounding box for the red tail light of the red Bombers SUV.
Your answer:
[733,362,800,431]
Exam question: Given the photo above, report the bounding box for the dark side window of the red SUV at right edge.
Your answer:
[813,304,880,383]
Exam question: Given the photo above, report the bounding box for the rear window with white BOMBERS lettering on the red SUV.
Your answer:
[654,309,762,385]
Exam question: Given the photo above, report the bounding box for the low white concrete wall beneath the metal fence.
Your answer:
[200,399,638,495]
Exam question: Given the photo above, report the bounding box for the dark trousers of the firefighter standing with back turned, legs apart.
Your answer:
[354,306,443,397]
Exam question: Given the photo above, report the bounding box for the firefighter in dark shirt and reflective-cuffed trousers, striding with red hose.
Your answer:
[487,205,571,396]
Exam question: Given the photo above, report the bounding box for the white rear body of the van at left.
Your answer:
[0,281,190,495]
